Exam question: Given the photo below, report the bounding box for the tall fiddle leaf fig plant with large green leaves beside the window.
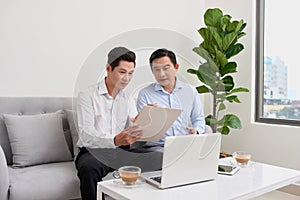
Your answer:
[187,8,249,135]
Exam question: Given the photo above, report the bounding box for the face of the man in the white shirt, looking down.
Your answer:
[107,60,134,90]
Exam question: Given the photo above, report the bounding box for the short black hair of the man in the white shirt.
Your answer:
[107,47,135,71]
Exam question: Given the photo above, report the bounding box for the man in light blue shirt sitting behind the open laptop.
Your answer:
[137,49,205,146]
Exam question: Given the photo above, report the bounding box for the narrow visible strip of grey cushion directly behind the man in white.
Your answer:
[64,109,79,157]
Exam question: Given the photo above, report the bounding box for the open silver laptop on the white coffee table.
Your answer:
[141,133,221,189]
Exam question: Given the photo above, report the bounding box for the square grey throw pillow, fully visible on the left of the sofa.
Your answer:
[3,111,72,167]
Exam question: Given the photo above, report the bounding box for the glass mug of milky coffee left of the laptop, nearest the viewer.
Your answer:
[113,166,141,185]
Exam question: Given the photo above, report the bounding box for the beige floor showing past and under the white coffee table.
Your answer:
[105,184,300,200]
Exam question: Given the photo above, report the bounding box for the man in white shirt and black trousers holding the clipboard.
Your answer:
[75,47,157,200]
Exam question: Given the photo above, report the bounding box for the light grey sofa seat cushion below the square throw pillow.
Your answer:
[8,162,80,200]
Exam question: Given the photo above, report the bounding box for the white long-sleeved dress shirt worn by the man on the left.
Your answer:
[77,79,137,148]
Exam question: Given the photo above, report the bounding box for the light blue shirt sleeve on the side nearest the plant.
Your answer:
[191,89,205,134]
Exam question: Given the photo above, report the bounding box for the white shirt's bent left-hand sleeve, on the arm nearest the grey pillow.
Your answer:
[77,92,116,148]
